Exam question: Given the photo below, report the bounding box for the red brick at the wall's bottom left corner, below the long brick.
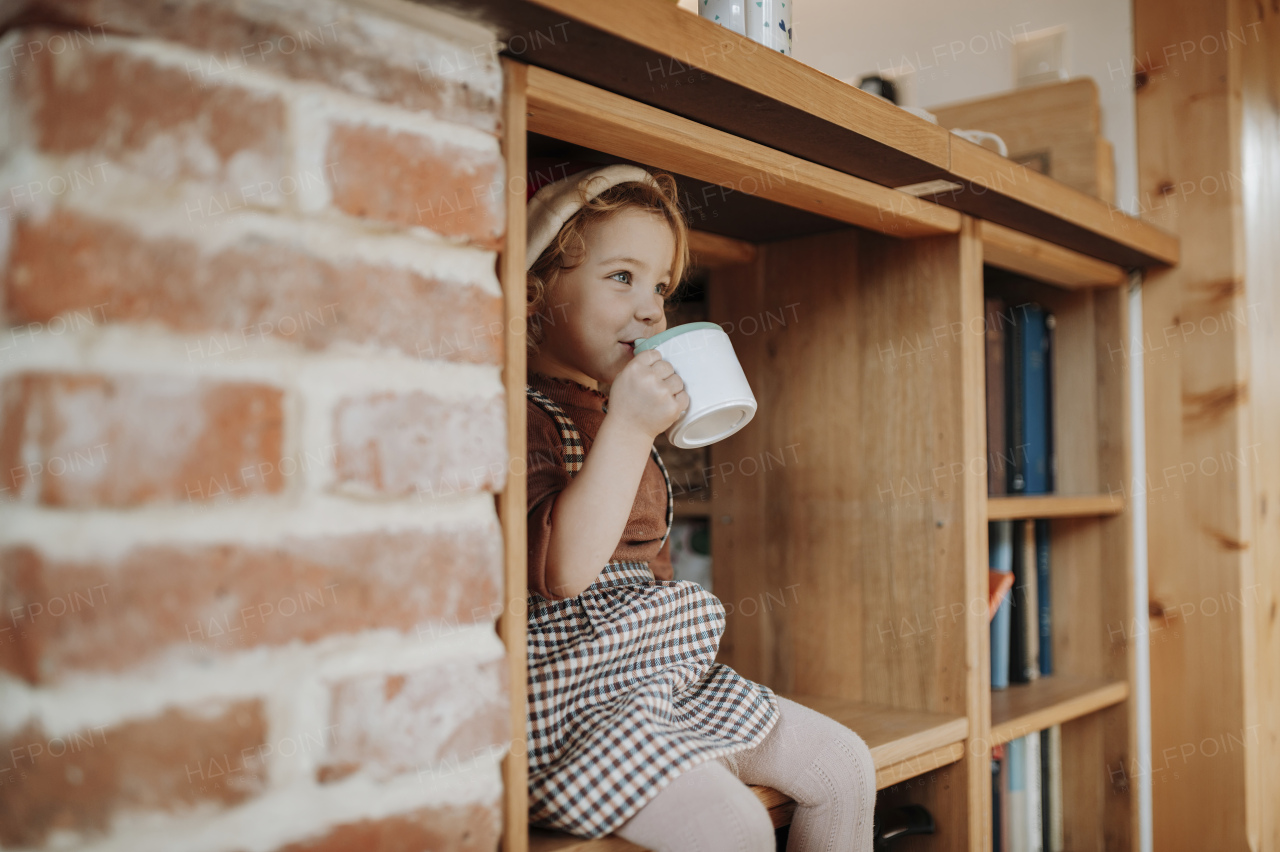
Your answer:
[0,700,268,847]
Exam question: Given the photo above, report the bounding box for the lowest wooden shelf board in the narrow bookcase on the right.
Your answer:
[991,674,1129,745]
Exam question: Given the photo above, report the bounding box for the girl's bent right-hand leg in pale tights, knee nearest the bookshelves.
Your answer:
[723,696,876,852]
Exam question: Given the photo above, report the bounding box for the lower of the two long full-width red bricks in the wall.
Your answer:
[0,519,502,683]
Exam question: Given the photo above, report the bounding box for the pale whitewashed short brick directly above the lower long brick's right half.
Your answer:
[333,391,507,499]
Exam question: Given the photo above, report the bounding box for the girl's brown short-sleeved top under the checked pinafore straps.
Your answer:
[526,374,675,600]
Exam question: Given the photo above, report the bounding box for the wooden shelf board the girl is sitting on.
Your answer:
[529,695,969,852]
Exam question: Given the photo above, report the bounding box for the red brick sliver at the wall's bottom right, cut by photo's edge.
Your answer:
[270,801,502,852]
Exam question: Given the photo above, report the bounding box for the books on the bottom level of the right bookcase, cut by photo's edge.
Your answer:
[991,725,1064,852]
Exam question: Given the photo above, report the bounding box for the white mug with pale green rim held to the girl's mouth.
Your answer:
[636,322,756,449]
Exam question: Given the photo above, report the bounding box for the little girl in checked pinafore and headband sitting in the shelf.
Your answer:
[526,164,876,852]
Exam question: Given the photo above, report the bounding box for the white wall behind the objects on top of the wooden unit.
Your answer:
[680,0,1138,212]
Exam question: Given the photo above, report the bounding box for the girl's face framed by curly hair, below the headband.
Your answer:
[529,209,676,388]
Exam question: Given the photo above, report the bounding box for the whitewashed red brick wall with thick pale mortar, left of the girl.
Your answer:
[0,0,511,852]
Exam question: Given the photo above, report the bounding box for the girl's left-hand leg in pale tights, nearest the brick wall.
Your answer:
[614,760,774,852]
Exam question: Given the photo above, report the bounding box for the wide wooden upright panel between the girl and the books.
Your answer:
[710,221,989,848]
